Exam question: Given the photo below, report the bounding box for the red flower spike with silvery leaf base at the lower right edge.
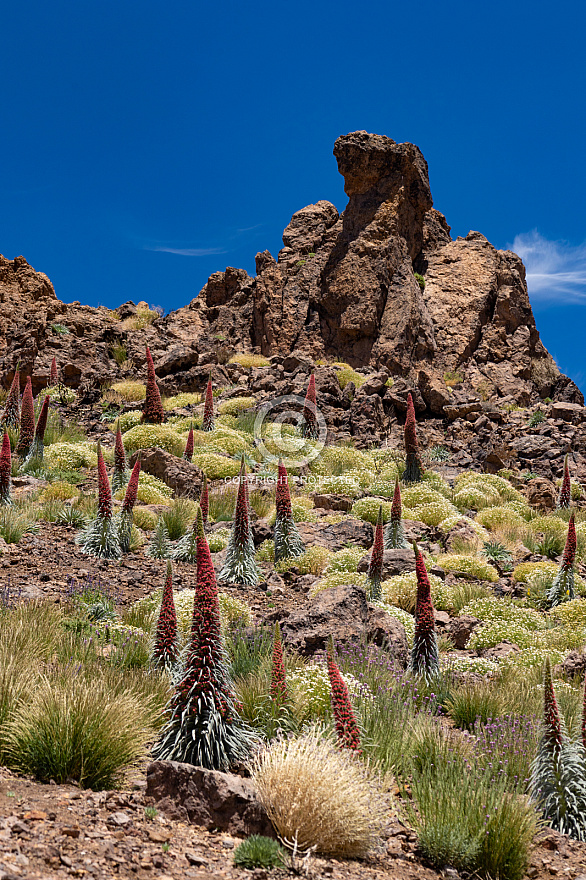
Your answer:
[529,657,586,840]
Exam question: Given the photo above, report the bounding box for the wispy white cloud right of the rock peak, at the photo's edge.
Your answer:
[510,229,586,303]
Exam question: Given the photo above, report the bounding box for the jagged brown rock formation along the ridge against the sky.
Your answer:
[0,132,583,416]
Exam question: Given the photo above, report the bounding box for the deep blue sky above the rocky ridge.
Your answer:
[0,0,586,385]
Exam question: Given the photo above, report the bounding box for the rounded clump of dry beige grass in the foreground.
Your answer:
[252,731,387,858]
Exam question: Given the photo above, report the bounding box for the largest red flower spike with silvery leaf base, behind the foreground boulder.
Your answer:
[153,510,256,771]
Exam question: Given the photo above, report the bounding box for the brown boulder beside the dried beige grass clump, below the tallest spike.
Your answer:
[145,761,275,837]
